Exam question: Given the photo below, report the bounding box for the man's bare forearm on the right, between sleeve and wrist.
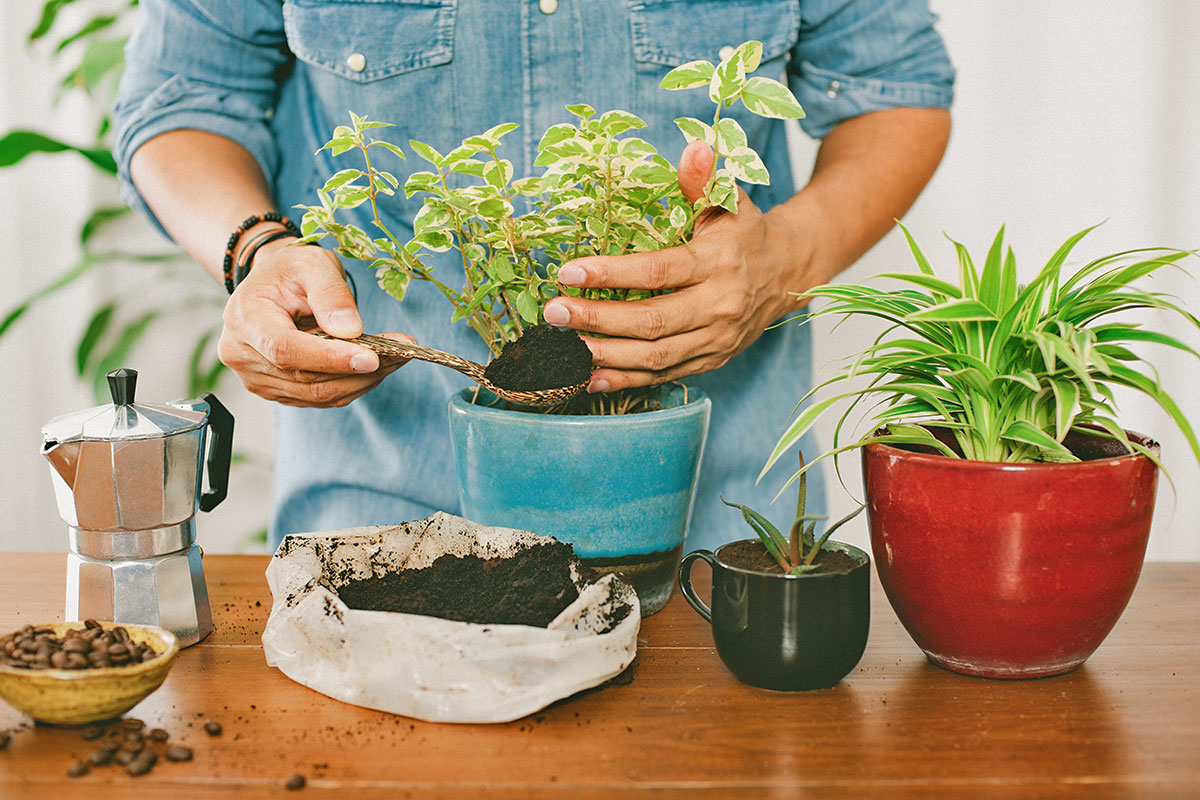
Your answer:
[768,108,950,307]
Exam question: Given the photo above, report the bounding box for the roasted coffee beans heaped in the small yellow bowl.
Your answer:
[0,619,160,669]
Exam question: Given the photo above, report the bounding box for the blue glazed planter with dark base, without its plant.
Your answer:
[449,386,712,616]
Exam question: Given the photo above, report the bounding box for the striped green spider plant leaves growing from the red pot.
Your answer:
[760,225,1200,491]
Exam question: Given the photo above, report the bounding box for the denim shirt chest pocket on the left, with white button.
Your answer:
[283,0,461,223]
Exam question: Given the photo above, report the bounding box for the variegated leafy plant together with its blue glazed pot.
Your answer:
[300,42,803,614]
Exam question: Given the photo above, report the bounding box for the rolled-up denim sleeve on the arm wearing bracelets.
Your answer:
[113,0,290,233]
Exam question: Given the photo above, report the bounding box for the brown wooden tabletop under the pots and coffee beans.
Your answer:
[0,553,1200,800]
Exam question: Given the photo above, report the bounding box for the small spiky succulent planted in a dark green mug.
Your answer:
[679,459,871,691]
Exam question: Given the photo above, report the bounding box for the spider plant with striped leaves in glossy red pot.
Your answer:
[763,228,1200,678]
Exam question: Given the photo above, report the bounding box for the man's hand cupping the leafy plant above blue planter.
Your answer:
[545,142,820,392]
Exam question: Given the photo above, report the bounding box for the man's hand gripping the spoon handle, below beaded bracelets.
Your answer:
[217,242,413,408]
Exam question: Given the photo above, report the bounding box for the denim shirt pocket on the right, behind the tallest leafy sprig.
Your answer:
[626,0,800,152]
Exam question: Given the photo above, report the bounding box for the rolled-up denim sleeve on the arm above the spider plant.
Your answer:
[787,0,954,138]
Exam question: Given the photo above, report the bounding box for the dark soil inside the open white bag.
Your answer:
[337,542,595,627]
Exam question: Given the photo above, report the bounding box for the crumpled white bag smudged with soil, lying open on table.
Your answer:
[263,513,641,722]
